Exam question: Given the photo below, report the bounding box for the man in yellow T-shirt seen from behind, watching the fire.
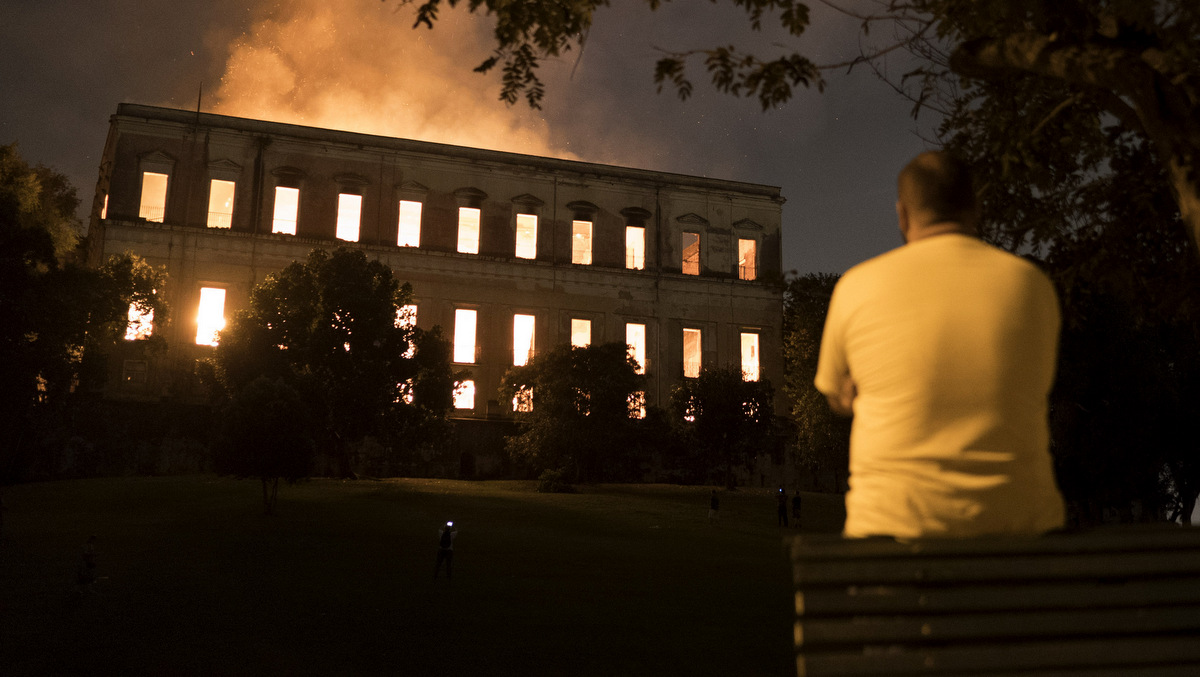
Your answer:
[815,152,1063,539]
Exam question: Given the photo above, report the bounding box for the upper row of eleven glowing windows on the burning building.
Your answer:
[131,172,758,280]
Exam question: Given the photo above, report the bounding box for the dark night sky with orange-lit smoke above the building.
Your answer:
[0,0,932,274]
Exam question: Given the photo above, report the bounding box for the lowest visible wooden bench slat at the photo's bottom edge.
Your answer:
[797,636,1200,677]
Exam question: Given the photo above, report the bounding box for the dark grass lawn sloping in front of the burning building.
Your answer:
[0,477,841,677]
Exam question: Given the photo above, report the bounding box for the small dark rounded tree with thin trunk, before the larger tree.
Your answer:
[212,376,314,515]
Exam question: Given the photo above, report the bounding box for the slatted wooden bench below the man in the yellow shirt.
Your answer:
[791,526,1200,677]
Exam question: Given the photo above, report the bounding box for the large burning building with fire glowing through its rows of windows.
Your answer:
[89,104,784,472]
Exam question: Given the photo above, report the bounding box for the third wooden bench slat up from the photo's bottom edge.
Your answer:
[796,577,1200,617]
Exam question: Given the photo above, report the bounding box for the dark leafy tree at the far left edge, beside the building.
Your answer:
[0,145,168,479]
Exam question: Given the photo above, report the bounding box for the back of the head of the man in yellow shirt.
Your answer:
[898,150,978,232]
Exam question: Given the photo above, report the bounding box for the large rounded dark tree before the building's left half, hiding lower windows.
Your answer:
[214,247,454,477]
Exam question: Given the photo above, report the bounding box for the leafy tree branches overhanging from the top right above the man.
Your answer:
[404,0,1200,256]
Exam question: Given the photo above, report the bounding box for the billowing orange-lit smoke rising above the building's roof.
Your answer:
[214,0,574,157]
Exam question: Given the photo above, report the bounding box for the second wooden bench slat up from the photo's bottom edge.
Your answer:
[794,606,1200,651]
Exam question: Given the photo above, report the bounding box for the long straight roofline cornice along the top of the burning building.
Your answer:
[113,103,785,203]
